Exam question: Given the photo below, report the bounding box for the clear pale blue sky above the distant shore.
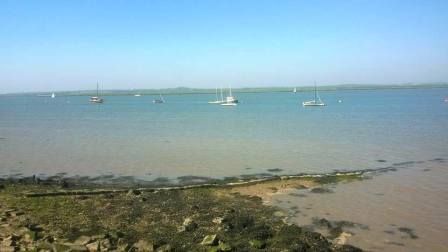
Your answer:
[0,0,448,93]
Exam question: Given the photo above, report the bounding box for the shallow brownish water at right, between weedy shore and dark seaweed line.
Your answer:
[273,160,448,251]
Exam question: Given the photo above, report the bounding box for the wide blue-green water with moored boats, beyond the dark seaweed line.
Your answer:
[0,89,448,180]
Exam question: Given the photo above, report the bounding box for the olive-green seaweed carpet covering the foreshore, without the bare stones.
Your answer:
[0,184,362,251]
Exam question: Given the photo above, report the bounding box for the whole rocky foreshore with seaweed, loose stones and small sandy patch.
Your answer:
[0,174,361,252]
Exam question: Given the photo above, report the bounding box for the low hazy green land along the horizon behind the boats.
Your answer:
[3,83,448,96]
